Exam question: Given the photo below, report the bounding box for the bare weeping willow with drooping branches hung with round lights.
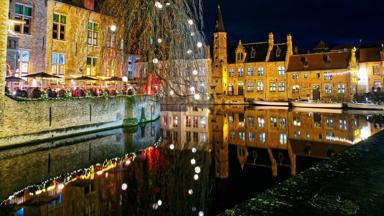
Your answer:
[100,0,208,99]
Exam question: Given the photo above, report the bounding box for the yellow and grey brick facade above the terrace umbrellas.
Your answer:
[7,0,123,85]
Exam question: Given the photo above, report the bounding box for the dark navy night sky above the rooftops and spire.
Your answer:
[203,0,384,51]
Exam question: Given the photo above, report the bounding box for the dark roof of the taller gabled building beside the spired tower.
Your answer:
[228,42,268,64]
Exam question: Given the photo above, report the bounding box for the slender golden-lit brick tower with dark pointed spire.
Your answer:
[209,5,228,95]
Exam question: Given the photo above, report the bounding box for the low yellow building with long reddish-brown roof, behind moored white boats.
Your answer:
[288,49,357,101]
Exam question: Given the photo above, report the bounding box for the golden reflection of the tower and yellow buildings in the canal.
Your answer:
[210,106,377,178]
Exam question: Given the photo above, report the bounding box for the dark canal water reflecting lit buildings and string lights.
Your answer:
[0,105,384,216]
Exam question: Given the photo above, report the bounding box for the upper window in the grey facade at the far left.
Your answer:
[14,4,32,34]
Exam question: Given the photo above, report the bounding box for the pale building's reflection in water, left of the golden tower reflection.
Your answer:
[160,105,209,150]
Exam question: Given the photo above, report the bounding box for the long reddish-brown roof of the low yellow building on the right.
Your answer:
[287,51,351,72]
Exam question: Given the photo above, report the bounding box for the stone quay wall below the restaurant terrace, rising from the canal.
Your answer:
[0,96,160,148]
